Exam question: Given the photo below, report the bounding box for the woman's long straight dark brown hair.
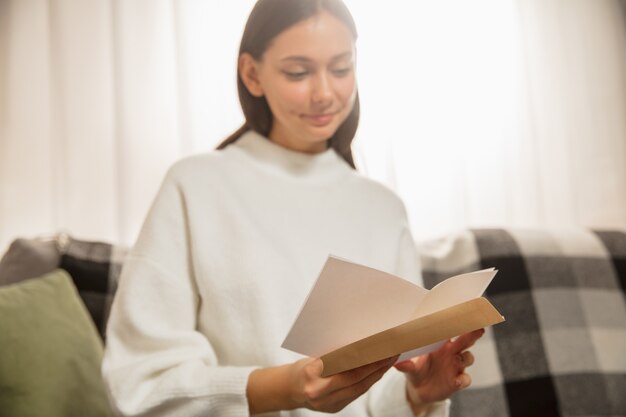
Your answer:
[217,0,360,168]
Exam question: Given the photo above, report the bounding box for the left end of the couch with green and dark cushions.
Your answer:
[0,234,126,417]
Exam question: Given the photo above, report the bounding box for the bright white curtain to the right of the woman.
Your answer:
[352,0,626,238]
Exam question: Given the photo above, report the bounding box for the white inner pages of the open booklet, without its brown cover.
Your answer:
[282,255,497,359]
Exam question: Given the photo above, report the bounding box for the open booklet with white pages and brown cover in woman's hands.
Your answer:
[282,256,504,377]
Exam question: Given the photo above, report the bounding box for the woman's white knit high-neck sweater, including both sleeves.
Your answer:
[103,132,447,417]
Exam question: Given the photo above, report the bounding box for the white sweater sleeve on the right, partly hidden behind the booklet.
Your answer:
[367,221,450,417]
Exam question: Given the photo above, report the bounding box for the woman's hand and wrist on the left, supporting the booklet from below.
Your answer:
[247,357,397,414]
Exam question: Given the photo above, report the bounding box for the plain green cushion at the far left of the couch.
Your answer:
[0,270,115,417]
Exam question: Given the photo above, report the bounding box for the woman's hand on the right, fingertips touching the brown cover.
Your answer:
[395,329,485,411]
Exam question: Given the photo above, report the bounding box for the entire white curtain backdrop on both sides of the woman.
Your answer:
[0,0,626,247]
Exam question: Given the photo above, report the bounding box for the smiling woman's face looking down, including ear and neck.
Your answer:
[240,11,356,153]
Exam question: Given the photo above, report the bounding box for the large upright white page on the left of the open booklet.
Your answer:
[282,256,428,357]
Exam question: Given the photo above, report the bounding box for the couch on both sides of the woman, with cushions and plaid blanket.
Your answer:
[0,229,626,417]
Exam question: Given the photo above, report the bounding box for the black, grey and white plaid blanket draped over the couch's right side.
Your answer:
[422,229,626,417]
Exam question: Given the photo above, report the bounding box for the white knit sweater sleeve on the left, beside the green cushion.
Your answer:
[102,167,253,417]
